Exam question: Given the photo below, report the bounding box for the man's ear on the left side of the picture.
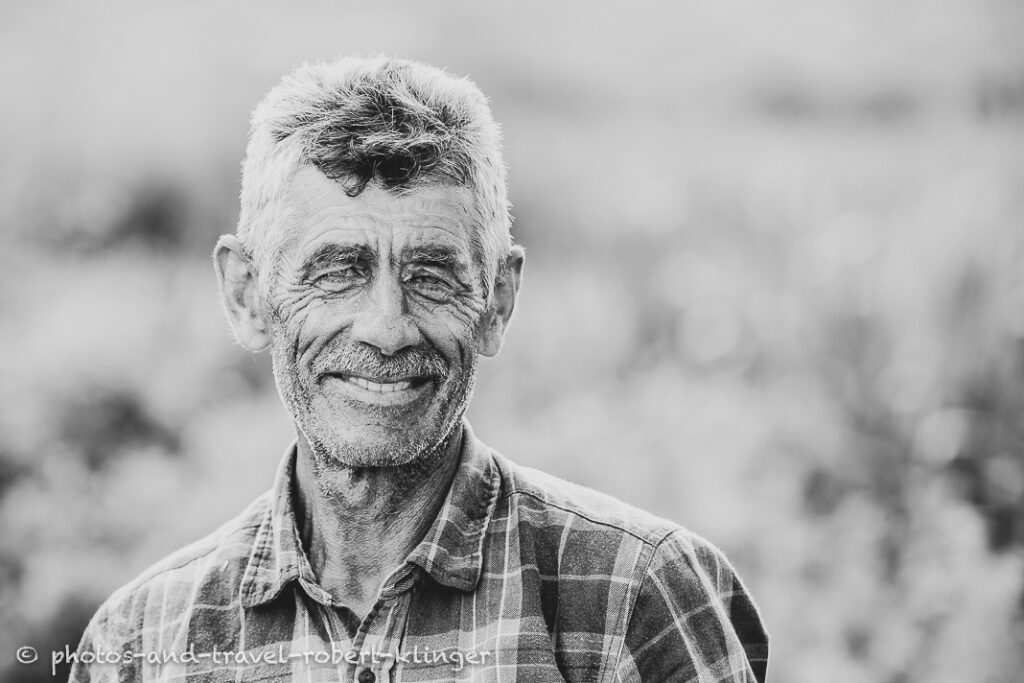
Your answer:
[213,234,270,353]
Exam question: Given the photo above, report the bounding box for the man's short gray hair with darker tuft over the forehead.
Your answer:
[237,56,512,294]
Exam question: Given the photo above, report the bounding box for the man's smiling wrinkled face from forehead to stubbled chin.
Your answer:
[267,167,486,467]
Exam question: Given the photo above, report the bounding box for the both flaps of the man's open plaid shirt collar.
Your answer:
[241,420,500,607]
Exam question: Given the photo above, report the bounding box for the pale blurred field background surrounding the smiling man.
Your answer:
[0,0,1024,683]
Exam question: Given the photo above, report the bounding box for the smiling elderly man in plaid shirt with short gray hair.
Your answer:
[72,57,768,683]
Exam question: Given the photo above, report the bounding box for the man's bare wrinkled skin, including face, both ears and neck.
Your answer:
[214,167,523,614]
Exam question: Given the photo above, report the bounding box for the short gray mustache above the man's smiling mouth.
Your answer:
[315,344,449,382]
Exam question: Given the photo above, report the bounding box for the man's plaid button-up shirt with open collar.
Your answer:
[71,425,768,683]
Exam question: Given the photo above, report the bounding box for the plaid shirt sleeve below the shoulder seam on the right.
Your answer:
[617,529,768,683]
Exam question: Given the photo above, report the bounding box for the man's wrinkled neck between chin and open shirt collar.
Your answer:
[295,427,463,617]
